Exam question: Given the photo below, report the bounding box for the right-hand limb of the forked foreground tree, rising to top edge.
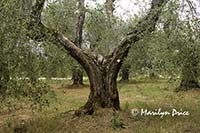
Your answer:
[108,0,168,64]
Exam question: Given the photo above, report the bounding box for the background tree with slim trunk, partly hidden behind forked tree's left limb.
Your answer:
[44,0,86,86]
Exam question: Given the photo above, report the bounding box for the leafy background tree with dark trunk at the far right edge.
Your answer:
[160,1,199,91]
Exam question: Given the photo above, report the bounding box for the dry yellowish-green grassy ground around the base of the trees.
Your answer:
[0,81,200,133]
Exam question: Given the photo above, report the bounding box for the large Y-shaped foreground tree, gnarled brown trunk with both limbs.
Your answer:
[28,0,167,116]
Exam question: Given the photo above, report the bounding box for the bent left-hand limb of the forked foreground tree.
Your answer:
[28,0,93,69]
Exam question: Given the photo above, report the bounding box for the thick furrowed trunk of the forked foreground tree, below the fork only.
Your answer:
[75,61,120,116]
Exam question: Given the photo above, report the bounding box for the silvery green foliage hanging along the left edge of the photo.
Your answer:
[0,0,55,106]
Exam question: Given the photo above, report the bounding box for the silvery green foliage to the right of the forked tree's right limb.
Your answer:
[126,1,200,78]
